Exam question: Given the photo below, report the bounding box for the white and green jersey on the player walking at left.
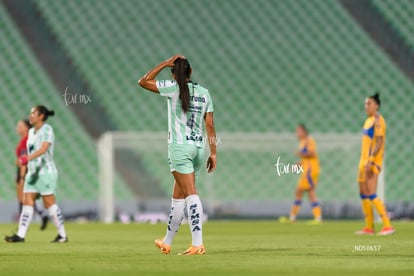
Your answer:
[27,124,57,174]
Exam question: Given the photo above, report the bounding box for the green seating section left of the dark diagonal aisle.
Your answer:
[0,3,129,201]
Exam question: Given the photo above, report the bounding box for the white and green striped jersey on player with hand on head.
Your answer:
[156,80,214,147]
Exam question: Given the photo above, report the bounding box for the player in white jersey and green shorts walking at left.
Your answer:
[4,105,68,243]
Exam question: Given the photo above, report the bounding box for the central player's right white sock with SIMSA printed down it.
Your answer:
[185,195,203,246]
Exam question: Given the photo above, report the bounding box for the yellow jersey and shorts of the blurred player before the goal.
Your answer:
[298,136,320,190]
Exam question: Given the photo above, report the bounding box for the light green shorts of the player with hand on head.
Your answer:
[168,144,205,175]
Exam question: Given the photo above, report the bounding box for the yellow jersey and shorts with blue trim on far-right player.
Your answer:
[360,113,387,168]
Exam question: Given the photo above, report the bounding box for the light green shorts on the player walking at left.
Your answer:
[23,173,58,195]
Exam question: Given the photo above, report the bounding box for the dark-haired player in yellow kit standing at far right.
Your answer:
[355,93,395,235]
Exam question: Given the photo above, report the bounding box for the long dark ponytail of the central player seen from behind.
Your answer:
[171,59,191,112]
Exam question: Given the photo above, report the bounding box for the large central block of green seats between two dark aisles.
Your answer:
[32,0,413,203]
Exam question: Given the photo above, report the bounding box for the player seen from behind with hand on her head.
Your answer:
[138,55,216,255]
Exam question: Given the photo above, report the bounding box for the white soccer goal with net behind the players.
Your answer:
[98,132,384,223]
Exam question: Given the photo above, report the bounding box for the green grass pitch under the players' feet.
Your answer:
[0,221,414,276]
